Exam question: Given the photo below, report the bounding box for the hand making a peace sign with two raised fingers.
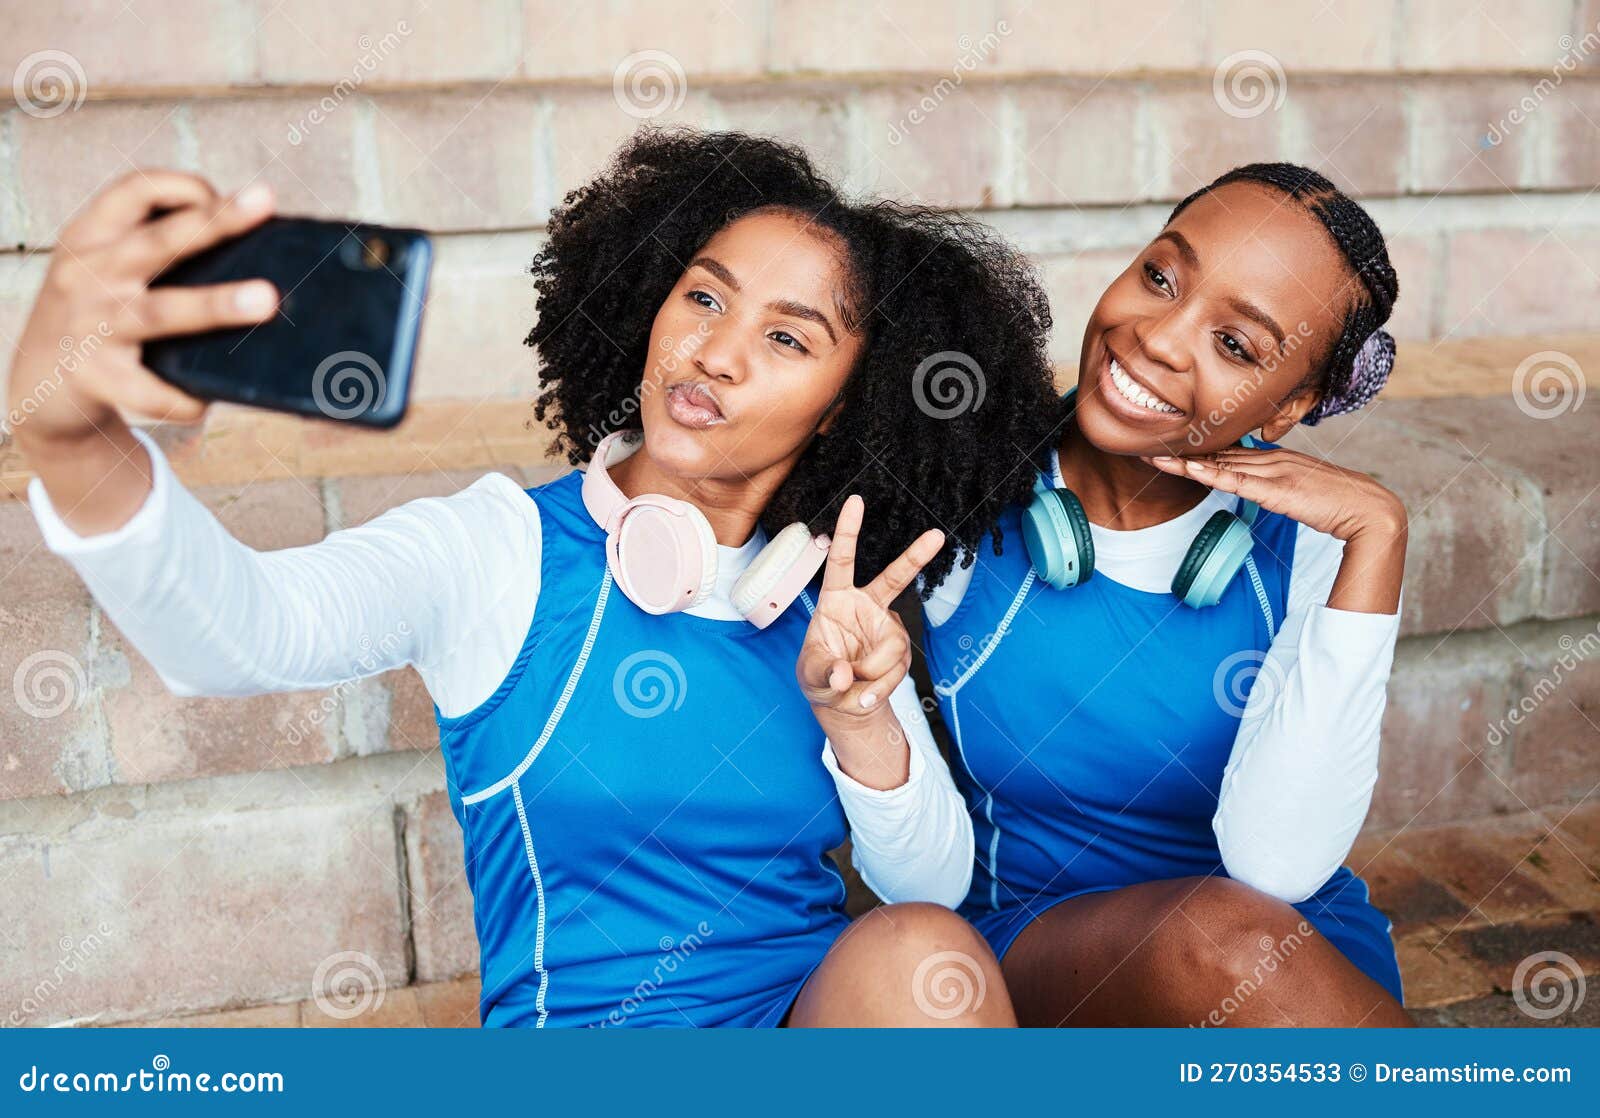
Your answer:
[795,494,944,717]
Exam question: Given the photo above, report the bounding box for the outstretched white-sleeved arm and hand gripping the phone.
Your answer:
[8,171,538,713]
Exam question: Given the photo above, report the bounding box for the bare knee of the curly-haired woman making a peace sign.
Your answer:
[784,904,1016,1028]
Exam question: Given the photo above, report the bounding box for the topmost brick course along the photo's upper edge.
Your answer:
[0,0,1594,96]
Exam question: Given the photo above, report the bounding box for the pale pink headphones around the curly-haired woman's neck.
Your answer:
[582,430,829,629]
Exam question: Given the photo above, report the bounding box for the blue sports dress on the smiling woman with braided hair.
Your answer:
[923,476,1402,998]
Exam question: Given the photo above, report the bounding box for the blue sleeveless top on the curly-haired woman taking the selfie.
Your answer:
[435,472,848,1027]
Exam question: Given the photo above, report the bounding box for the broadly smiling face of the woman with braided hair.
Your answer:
[1077,182,1352,454]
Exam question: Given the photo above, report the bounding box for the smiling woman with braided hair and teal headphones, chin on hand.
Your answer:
[923,163,1410,1025]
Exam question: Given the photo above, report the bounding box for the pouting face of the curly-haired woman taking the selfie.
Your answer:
[640,211,862,481]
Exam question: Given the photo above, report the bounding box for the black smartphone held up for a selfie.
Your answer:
[144,218,434,427]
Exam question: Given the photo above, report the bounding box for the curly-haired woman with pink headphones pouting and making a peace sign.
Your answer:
[10,131,1054,1027]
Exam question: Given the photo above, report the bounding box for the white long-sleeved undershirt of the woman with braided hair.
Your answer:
[926,441,1400,902]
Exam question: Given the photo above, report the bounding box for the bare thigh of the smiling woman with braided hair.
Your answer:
[1003,878,1410,1025]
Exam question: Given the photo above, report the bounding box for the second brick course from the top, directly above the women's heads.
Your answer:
[0,71,1600,246]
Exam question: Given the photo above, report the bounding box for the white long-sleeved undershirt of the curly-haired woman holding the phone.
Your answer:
[27,429,973,907]
